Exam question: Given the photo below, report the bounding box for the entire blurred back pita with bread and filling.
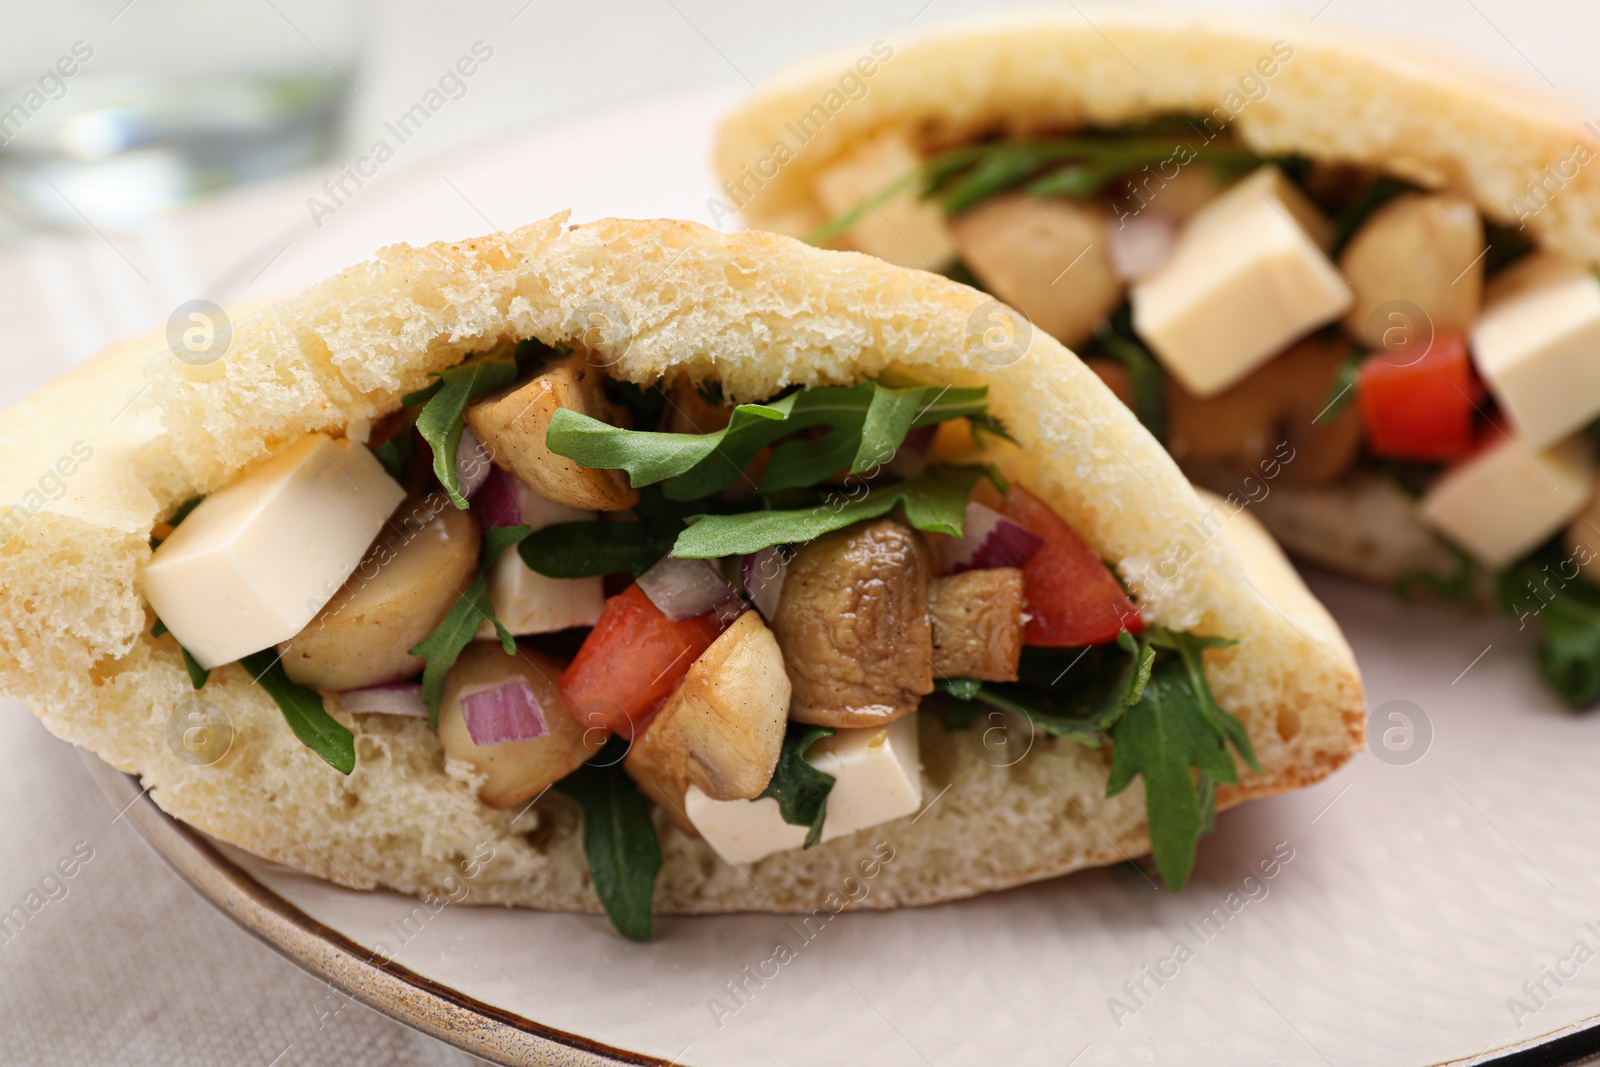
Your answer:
[715,10,1600,707]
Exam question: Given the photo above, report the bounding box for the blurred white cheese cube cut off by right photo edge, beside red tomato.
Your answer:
[1472,270,1600,448]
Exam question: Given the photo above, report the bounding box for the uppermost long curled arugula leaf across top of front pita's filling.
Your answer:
[546,381,987,501]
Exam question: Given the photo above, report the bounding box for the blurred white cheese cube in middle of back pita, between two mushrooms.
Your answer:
[1131,166,1354,397]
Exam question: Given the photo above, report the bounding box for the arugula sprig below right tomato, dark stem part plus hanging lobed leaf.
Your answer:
[939,627,1261,893]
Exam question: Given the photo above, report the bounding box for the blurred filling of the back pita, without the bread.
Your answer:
[810,117,1600,707]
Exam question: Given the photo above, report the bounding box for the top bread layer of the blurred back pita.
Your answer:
[714,8,1600,261]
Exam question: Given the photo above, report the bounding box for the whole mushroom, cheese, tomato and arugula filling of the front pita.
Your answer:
[144,342,1259,936]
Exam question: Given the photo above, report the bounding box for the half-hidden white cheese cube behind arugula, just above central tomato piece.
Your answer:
[478,482,605,640]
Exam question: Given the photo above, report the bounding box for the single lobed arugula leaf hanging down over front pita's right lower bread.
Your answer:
[1106,662,1238,893]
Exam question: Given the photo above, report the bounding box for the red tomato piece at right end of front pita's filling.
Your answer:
[1000,483,1144,648]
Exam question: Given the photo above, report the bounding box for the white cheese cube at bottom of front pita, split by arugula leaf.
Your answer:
[683,715,922,864]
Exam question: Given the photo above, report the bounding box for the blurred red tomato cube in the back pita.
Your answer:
[1357,333,1483,462]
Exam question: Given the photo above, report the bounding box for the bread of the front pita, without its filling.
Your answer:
[0,216,1363,912]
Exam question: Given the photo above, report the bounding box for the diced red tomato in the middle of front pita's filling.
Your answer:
[558,584,723,737]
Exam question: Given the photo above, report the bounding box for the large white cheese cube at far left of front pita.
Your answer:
[144,434,405,667]
